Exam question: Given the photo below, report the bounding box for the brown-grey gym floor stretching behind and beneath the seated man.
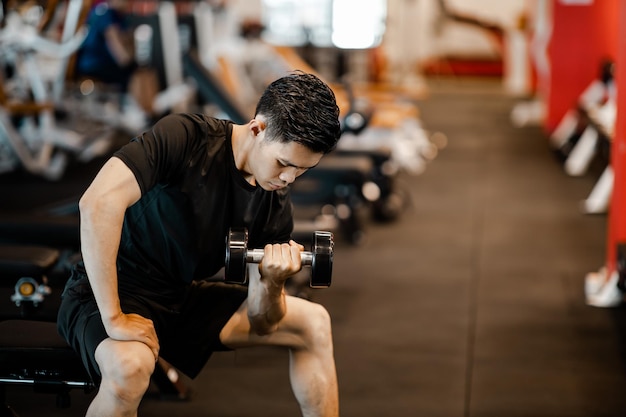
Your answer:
[0,79,626,417]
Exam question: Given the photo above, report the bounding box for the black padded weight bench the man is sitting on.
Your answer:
[0,240,190,410]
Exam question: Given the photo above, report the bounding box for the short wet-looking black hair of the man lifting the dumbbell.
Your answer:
[255,71,341,154]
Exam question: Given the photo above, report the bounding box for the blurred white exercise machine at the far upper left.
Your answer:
[0,0,112,180]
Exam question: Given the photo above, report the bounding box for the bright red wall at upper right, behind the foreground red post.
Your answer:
[545,0,623,132]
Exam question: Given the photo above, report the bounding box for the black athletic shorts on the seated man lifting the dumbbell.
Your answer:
[57,271,248,381]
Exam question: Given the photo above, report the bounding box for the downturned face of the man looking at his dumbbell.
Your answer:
[250,134,323,191]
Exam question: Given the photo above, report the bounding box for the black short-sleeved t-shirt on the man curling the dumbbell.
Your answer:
[115,114,293,289]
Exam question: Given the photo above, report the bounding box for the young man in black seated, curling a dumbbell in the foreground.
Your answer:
[58,72,340,417]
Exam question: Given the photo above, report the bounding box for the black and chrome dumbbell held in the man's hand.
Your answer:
[225,228,334,288]
